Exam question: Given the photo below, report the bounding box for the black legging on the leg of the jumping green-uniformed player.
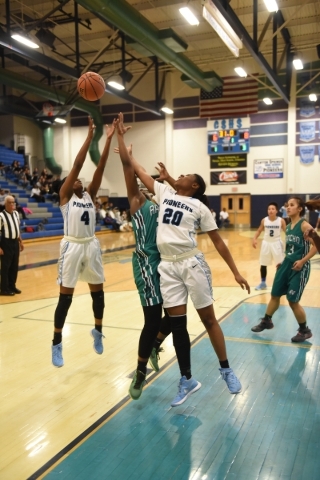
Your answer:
[138,303,162,358]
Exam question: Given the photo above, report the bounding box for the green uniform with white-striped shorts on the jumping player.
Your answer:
[132,200,162,306]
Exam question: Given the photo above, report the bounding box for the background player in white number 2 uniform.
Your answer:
[252,202,286,290]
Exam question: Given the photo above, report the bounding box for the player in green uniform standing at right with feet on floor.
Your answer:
[251,197,317,342]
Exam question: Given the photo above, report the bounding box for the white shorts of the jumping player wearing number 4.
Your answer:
[57,237,104,288]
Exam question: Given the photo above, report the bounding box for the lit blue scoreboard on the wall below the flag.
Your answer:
[207,128,250,155]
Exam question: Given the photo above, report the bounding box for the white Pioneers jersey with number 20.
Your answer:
[154,181,218,255]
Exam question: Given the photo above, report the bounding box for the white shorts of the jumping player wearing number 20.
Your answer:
[158,253,213,310]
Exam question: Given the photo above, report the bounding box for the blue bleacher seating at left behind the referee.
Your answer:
[0,145,101,239]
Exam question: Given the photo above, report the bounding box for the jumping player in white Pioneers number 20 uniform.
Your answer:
[117,114,250,406]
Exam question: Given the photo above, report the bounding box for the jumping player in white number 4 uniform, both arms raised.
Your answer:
[52,117,115,367]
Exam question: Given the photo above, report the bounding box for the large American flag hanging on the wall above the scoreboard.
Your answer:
[200,77,258,118]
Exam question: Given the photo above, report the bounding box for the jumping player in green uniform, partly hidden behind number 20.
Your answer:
[115,122,178,400]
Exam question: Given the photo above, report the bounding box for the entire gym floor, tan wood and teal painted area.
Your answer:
[0,230,320,480]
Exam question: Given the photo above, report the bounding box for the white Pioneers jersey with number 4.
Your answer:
[60,192,96,238]
